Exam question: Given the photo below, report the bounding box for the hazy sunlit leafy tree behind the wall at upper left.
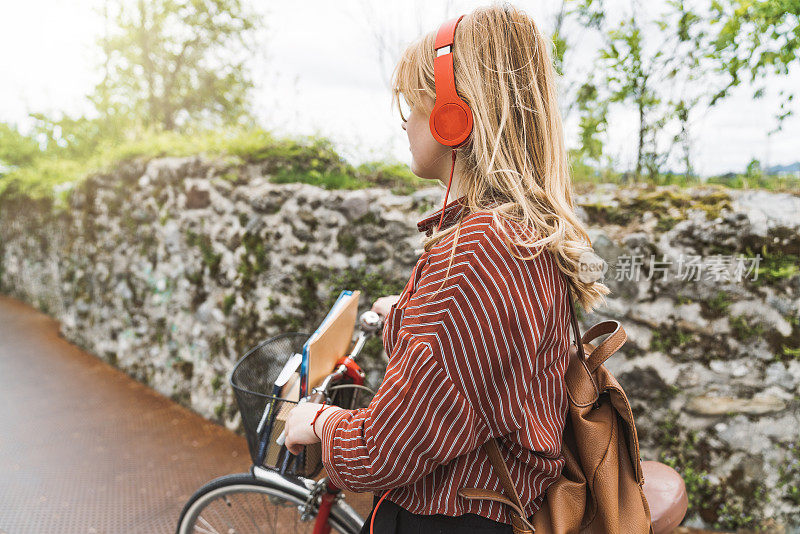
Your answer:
[90,0,261,130]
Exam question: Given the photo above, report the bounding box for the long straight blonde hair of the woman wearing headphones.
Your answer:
[392,3,610,312]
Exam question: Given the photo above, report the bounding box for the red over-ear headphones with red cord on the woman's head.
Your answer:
[429,15,472,230]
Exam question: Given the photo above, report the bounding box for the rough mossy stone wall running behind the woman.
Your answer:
[0,157,800,531]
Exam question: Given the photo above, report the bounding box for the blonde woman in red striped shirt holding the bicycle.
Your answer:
[286,5,608,533]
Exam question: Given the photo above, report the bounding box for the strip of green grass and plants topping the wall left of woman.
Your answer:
[0,123,430,202]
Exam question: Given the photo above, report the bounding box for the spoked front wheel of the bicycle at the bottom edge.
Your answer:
[176,470,364,534]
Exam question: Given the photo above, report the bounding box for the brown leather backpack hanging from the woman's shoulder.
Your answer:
[458,278,653,534]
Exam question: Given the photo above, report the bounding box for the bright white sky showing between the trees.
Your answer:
[0,0,800,176]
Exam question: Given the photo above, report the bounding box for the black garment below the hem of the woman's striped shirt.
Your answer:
[359,495,513,534]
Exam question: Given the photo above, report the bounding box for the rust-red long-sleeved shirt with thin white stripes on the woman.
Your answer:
[322,197,570,523]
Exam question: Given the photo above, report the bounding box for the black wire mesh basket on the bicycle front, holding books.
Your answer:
[231,332,323,478]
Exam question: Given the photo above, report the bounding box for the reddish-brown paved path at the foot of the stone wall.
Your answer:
[0,295,372,534]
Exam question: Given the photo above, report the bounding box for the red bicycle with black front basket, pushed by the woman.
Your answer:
[176,311,384,534]
